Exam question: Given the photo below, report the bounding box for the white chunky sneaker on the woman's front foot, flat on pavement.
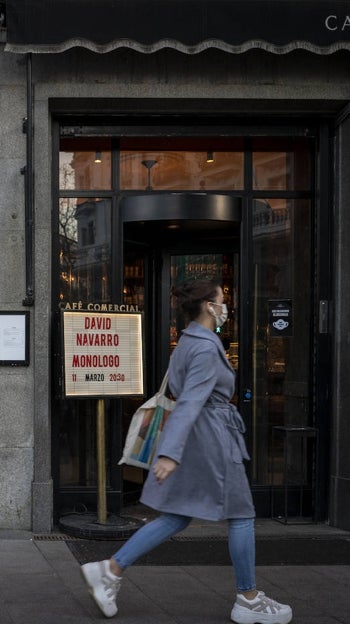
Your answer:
[231,592,293,624]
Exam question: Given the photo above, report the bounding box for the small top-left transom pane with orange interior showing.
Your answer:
[59,138,112,191]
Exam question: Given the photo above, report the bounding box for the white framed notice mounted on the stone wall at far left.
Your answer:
[0,310,30,366]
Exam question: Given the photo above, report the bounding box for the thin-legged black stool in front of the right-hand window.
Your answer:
[271,426,318,524]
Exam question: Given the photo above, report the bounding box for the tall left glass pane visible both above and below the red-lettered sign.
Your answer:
[58,197,111,486]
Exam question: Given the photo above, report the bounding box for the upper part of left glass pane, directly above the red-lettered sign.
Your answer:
[59,197,111,303]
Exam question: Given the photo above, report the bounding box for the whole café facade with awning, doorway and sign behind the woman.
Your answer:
[0,0,350,532]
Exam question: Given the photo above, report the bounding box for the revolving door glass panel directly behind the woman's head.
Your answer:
[170,252,239,369]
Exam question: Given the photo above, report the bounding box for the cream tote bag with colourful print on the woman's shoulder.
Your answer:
[118,371,175,470]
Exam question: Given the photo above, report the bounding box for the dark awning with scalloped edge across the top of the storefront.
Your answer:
[6,0,350,54]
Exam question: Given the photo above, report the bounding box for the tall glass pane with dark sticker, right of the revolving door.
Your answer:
[252,199,311,485]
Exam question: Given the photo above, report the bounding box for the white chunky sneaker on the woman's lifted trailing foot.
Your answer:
[80,559,121,617]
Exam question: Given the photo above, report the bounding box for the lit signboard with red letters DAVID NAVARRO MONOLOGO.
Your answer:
[61,310,145,399]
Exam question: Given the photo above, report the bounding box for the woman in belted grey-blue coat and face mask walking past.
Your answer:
[81,280,292,624]
